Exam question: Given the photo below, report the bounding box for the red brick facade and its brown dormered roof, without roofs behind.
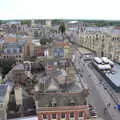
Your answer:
[37,91,88,120]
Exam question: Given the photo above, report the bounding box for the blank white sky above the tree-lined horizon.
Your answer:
[0,0,120,20]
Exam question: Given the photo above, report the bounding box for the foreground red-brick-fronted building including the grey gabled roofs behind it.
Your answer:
[34,58,89,120]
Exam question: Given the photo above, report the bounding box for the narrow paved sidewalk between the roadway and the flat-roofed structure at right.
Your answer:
[86,65,120,120]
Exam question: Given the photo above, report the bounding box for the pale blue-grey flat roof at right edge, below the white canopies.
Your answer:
[106,64,120,87]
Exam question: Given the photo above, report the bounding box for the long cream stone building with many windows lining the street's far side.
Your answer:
[75,28,120,62]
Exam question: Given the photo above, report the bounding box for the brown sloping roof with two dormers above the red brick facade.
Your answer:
[36,90,88,111]
